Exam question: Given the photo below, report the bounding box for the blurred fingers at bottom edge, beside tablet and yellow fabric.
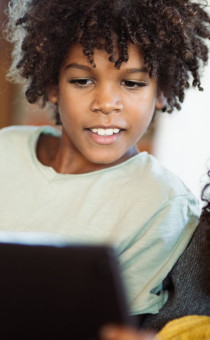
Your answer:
[99,325,155,340]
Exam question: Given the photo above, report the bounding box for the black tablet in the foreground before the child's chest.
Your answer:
[0,243,130,340]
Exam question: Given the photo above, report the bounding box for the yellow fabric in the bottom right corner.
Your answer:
[155,315,210,340]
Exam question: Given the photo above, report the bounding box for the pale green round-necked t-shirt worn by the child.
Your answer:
[0,127,200,314]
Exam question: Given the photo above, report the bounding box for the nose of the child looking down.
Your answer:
[91,88,123,114]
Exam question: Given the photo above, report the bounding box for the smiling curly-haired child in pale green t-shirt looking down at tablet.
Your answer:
[0,0,210,326]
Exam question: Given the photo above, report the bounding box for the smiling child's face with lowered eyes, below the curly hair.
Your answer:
[49,44,163,173]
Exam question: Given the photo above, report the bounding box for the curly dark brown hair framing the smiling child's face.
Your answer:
[4,0,210,117]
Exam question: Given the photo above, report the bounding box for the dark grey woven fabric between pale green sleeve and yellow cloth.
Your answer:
[141,222,210,330]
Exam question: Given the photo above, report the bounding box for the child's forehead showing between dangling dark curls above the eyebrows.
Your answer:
[63,43,144,69]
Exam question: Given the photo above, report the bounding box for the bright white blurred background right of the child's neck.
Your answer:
[153,0,210,205]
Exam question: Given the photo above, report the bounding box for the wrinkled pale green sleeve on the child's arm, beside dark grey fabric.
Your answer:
[118,195,200,315]
